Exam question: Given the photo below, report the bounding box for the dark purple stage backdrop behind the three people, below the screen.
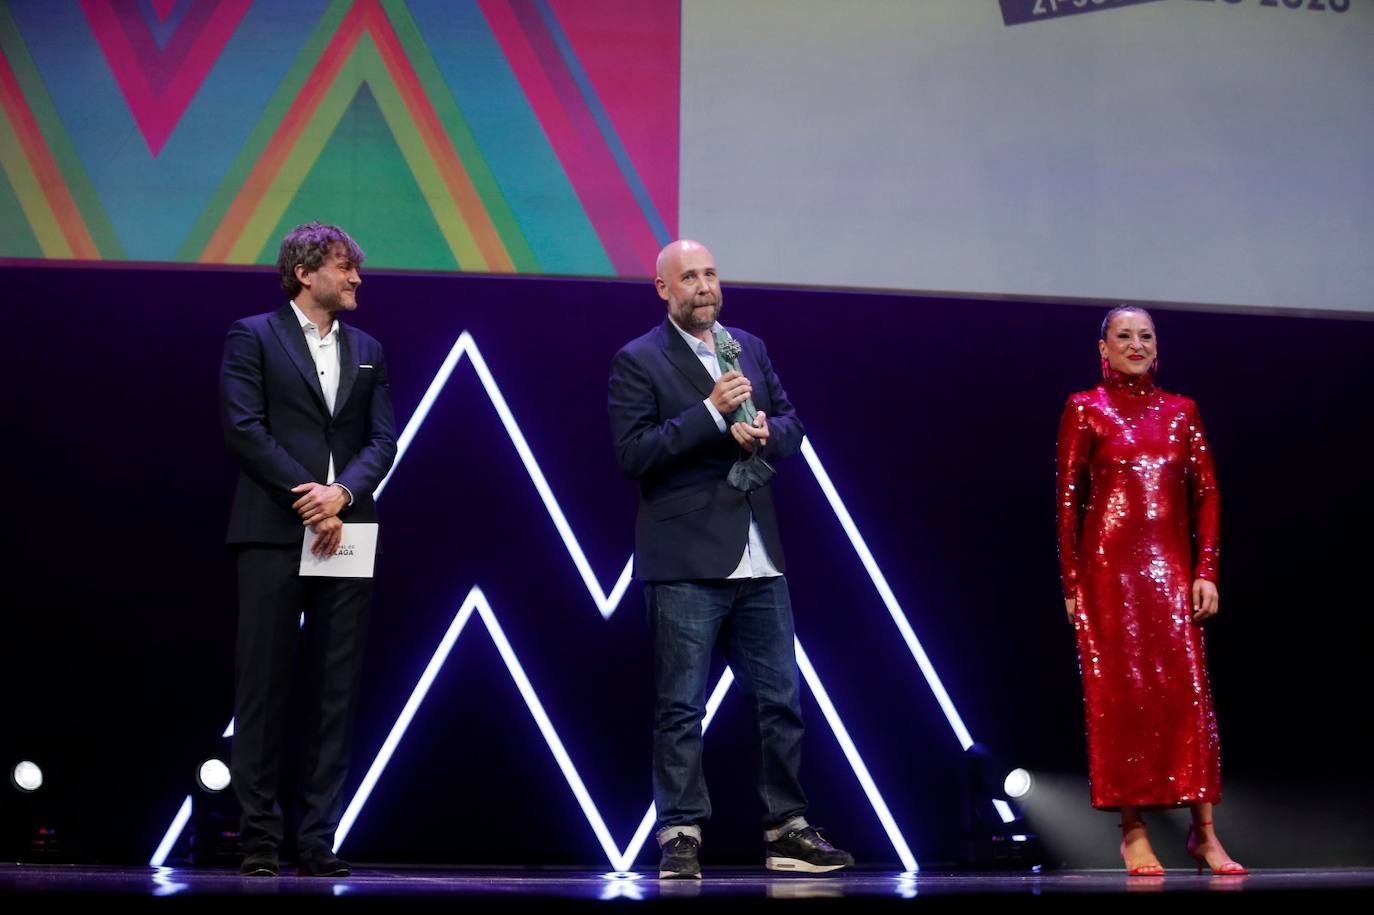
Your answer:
[0,259,1374,866]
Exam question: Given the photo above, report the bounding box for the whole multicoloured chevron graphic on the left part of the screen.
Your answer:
[0,0,680,276]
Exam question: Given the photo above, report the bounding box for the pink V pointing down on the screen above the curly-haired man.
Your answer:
[81,0,251,157]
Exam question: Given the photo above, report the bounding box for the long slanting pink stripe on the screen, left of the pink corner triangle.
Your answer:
[480,0,658,276]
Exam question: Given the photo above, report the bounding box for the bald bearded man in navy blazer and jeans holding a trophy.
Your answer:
[610,240,853,878]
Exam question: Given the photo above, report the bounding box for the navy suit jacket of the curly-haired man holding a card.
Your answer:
[220,305,396,544]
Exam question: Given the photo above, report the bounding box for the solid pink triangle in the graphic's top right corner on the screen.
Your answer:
[550,0,682,235]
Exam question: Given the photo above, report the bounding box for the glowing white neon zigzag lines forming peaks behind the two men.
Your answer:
[150,331,983,872]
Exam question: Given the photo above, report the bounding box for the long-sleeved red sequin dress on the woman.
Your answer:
[1058,371,1221,809]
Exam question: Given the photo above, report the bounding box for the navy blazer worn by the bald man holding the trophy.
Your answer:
[610,317,805,581]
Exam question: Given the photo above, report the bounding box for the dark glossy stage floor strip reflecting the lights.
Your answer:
[0,864,1374,910]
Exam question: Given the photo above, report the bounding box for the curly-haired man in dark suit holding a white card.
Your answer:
[220,223,396,877]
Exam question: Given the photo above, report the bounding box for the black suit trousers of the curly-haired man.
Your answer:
[231,544,372,853]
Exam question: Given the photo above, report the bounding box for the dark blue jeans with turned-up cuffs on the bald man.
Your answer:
[644,576,807,830]
